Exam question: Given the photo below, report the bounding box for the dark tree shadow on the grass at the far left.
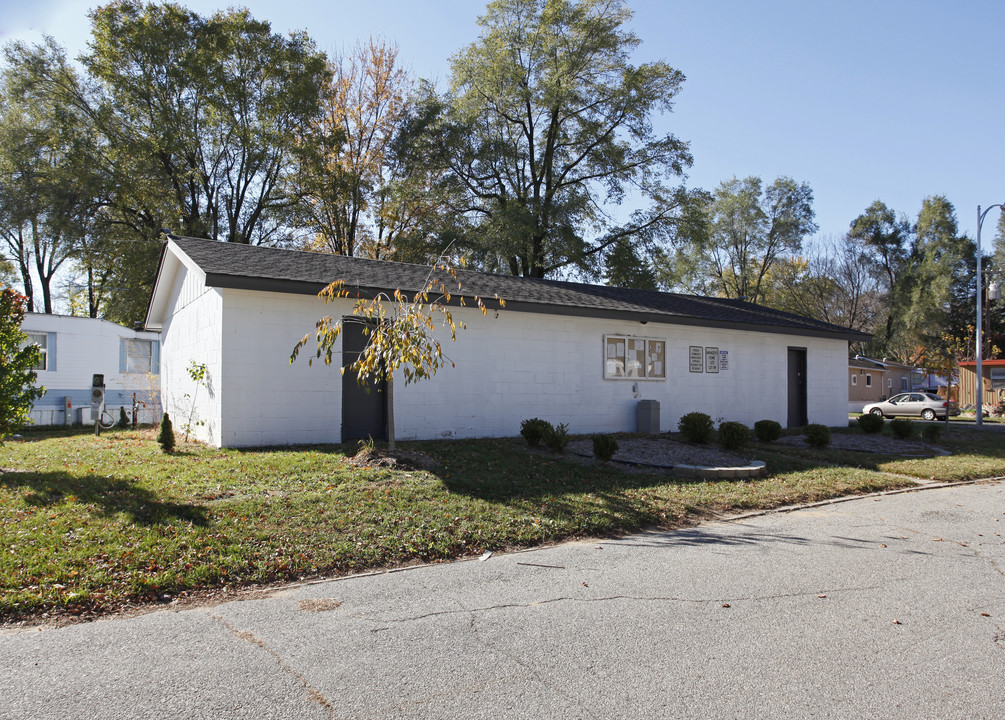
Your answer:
[0,472,209,526]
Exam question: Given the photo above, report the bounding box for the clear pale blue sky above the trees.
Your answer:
[0,0,1005,244]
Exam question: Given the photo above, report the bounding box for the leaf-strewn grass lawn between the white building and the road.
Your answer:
[0,427,1005,622]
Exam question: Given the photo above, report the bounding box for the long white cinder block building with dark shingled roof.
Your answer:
[147,237,863,446]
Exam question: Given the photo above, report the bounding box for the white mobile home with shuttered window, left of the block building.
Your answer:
[21,313,161,425]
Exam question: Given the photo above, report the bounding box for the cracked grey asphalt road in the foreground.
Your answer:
[0,483,1005,720]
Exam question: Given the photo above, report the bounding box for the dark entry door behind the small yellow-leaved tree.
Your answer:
[342,320,387,442]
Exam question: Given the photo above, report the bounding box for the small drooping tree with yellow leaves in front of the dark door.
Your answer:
[289,255,506,451]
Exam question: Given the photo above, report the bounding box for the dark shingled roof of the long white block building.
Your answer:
[171,236,869,340]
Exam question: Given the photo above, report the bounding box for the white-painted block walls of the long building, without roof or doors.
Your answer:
[189,290,847,446]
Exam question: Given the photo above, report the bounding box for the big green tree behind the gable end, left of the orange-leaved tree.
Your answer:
[82,0,327,243]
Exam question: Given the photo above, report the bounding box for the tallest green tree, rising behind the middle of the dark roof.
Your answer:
[426,0,691,278]
